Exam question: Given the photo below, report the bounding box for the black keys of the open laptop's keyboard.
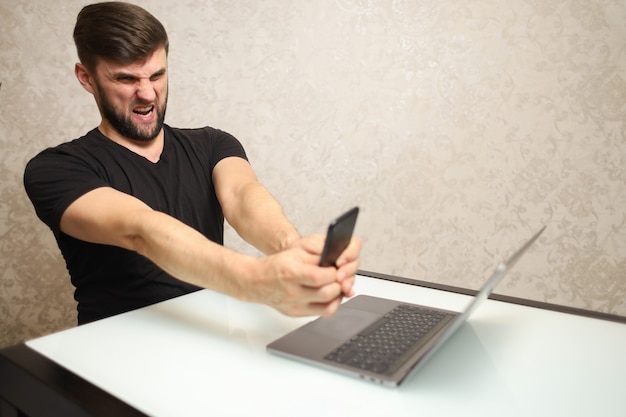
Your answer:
[324,304,454,374]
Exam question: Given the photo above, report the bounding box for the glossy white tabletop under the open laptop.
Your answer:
[0,276,626,417]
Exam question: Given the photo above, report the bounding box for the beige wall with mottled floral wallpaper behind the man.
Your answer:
[0,0,626,346]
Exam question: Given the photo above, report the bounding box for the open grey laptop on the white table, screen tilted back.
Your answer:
[267,226,546,386]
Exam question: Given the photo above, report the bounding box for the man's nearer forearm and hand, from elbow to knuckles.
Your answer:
[134,208,353,316]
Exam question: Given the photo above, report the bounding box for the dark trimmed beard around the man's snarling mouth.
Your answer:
[96,83,167,142]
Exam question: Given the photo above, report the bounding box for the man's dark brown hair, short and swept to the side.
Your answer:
[74,1,169,71]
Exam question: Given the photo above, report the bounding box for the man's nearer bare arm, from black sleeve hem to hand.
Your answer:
[61,180,358,316]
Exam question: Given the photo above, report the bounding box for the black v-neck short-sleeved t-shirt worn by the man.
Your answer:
[24,126,247,324]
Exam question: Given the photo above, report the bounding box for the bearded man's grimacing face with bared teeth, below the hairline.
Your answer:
[94,48,167,142]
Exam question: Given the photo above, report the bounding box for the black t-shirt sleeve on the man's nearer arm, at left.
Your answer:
[24,149,108,234]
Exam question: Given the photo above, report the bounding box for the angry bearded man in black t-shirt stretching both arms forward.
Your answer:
[24,2,360,324]
